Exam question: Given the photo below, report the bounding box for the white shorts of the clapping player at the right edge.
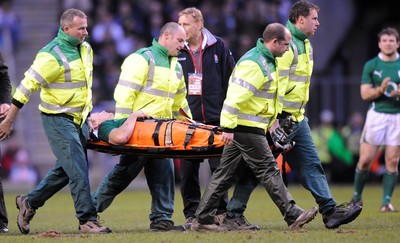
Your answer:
[360,108,400,146]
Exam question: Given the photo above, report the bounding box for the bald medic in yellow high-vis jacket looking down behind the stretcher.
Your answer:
[92,22,195,231]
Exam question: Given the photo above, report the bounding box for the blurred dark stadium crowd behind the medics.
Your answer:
[0,0,400,188]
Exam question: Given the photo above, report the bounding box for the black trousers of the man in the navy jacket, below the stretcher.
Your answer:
[180,157,228,218]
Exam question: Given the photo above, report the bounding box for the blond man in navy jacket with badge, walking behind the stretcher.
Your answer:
[178,8,235,228]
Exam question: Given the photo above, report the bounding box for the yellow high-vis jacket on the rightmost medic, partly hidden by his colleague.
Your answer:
[277,21,314,122]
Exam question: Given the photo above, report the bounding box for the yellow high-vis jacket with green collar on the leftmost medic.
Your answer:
[13,28,93,125]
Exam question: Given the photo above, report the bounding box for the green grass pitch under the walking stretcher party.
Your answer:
[0,184,400,243]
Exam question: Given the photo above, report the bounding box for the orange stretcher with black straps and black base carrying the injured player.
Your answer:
[87,119,224,158]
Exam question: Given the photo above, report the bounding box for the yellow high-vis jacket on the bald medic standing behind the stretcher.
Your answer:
[114,40,191,119]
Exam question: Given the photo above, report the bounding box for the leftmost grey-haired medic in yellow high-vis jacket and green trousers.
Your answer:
[0,8,111,234]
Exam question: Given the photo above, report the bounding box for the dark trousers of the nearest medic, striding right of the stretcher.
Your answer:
[195,132,304,225]
